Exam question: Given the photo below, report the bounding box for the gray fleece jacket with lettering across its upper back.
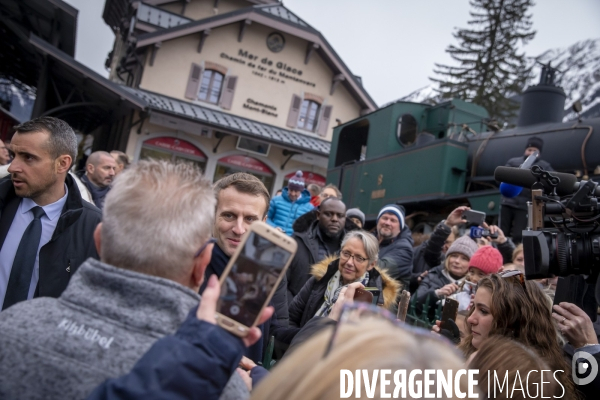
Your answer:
[0,258,249,400]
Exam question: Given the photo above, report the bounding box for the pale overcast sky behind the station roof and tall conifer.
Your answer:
[65,0,600,105]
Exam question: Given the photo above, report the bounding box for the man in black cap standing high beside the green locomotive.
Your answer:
[500,136,554,243]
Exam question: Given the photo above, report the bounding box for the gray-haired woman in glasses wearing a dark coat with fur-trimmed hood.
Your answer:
[289,230,400,327]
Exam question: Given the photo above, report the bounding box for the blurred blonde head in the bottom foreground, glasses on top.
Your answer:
[251,310,468,400]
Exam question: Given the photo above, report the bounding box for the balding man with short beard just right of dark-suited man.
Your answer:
[81,151,117,210]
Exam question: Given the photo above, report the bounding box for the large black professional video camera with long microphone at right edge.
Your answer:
[494,165,600,286]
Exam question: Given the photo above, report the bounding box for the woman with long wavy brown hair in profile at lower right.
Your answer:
[459,271,576,399]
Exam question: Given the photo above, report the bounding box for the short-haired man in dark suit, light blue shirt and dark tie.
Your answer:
[0,117,102,310]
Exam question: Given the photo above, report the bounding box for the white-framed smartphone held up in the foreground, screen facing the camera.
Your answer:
[216,221,297,337]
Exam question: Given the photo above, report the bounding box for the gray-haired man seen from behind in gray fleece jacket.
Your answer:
[0,161,249,399]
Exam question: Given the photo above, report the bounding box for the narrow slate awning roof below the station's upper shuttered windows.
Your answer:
[121,86,331,157]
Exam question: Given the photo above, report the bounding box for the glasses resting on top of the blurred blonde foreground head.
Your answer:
[323,302,458,358]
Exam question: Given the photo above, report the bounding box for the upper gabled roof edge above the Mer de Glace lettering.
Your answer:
[137,4,377,111]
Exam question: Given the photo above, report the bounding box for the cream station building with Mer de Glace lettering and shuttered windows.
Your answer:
[103,0,376,193]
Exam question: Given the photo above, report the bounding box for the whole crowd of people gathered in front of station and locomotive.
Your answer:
[0,117,600,399]
